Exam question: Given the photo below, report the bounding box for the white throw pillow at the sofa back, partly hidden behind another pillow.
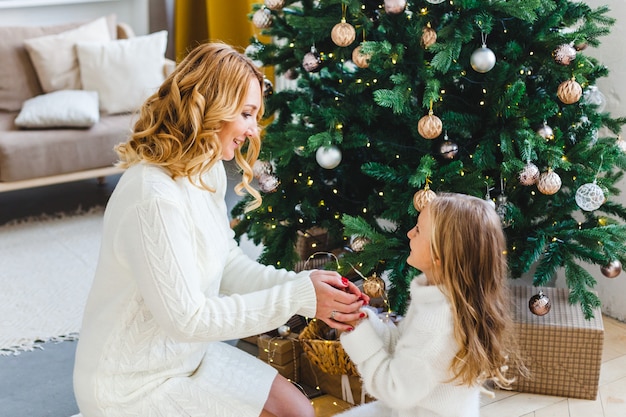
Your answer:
[24,17,111,93]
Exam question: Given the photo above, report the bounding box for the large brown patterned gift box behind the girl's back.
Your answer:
[512,286,604,400]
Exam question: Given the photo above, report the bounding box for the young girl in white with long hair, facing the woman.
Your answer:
[341,194,515,417]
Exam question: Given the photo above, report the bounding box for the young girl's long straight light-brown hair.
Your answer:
[428,193,525,387]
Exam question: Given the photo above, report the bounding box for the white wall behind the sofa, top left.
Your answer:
[0,0,149,35]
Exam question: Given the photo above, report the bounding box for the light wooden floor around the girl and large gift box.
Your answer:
[313,316,626,417]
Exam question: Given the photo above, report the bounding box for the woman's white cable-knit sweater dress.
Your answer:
[74,162,316,417]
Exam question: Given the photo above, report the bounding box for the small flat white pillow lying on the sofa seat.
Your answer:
[15,90,100,129]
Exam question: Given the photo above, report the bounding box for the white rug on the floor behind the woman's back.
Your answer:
[0,209,103,355]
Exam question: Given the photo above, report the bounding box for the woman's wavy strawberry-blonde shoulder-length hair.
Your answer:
[115,43,264,210]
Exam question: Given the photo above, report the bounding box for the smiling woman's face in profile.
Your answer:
[217,78,261,161]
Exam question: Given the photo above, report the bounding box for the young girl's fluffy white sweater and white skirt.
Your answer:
[341,276,480,417]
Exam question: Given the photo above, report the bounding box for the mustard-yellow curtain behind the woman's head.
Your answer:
[174,0,262,61]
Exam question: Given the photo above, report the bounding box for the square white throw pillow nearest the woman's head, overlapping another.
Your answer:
[76,30,167,114]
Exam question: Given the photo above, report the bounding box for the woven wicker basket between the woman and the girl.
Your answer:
[298,320,359,376]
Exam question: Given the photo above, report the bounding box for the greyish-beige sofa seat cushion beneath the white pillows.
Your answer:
[0,112,135,181]
